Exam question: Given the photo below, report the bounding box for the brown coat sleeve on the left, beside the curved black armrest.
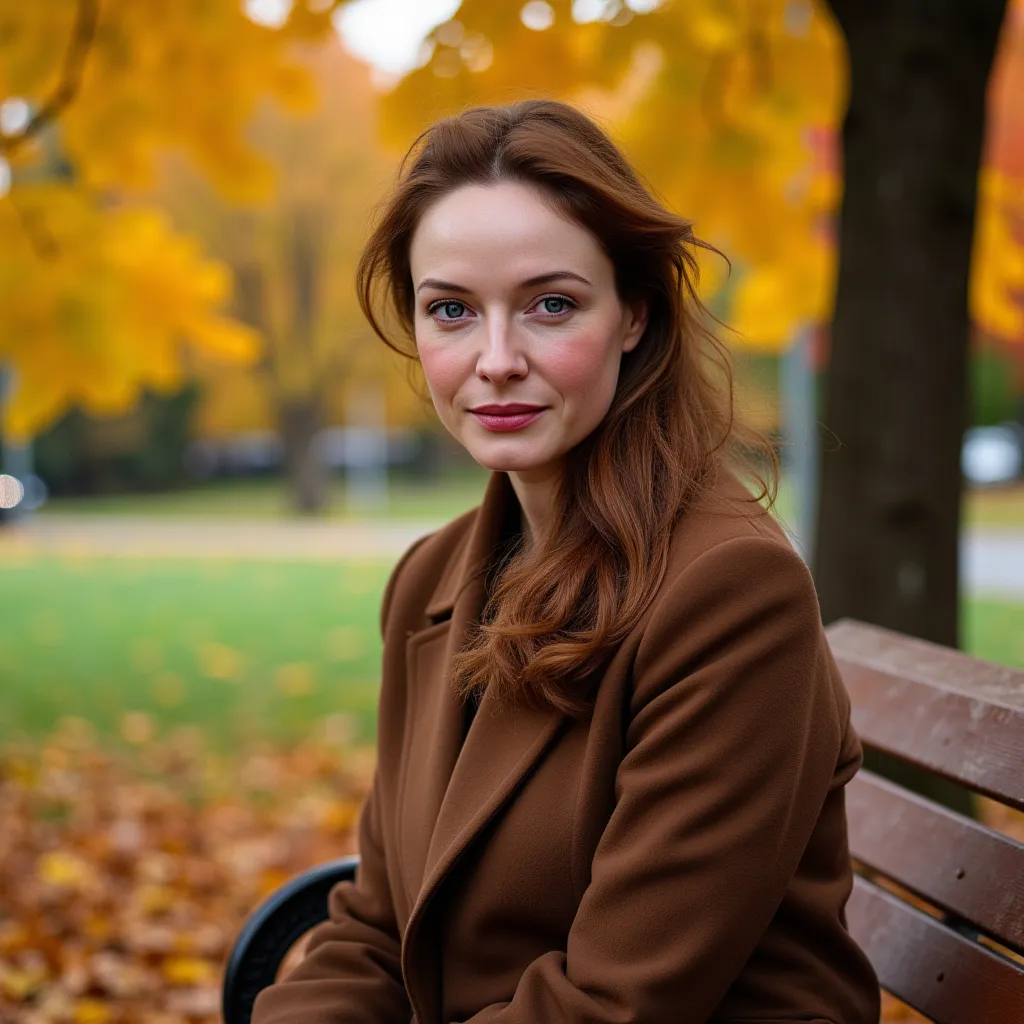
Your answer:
[252,538,434,1024]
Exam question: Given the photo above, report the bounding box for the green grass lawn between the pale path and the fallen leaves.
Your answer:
[0,556,1024,751]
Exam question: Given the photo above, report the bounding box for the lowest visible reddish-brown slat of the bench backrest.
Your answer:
[847,876,1024,1024]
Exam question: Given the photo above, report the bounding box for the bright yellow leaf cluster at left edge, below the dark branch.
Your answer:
[0,183,258,436]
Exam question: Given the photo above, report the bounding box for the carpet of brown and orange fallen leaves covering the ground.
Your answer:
[0,712,1024,1024]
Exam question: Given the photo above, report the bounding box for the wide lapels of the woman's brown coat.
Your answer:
[402,472,565,1024]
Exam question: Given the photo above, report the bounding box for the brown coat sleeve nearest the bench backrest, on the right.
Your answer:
[452,535,842,1024]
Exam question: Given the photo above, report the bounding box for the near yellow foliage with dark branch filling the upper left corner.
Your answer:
[0,0,344,438]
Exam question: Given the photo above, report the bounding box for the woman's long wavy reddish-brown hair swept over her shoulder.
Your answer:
[356,99,778,717]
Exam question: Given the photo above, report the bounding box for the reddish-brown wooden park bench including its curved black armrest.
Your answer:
[223,620,1024,1024]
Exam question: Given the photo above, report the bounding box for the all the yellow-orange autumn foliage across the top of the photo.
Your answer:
[0,0,1024,438]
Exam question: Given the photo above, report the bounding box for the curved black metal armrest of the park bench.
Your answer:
[221,856,359,1024]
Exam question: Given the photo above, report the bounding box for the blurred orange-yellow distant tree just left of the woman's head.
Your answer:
[152,36,423,512]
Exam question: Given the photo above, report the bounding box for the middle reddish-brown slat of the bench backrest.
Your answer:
[846,769,1024,952]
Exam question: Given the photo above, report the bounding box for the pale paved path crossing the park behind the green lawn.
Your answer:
[0,515,1024,599]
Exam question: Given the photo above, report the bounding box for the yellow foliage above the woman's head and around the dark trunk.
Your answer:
[384,0,1024,351]
